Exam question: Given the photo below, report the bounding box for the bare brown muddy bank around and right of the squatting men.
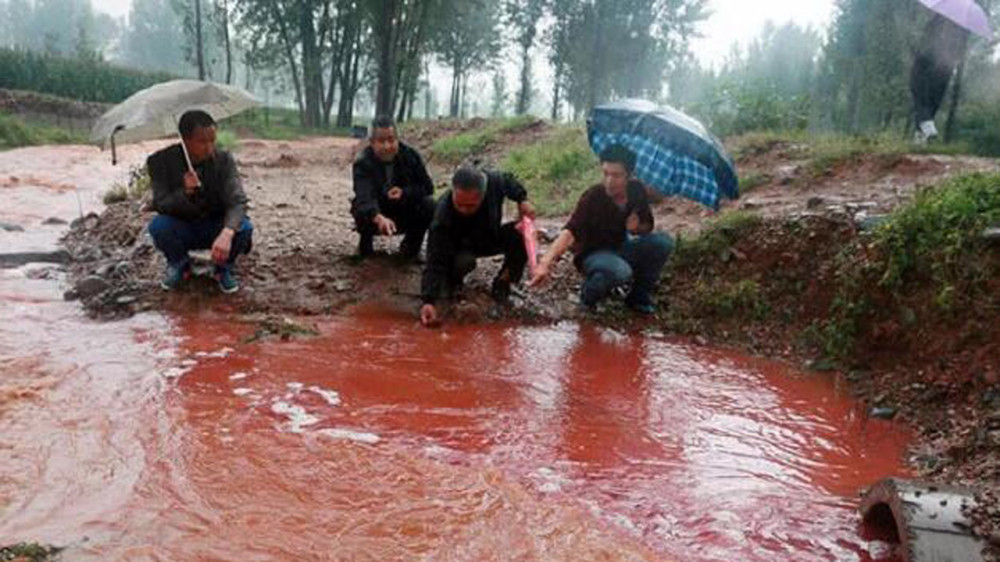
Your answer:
[58,130,1000,556]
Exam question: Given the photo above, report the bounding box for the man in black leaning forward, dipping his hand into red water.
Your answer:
[420,167,535,326]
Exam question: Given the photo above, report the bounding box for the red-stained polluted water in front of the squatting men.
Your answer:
[0,282,908,561]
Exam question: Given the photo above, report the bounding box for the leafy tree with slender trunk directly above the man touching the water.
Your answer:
[433,0,500,117]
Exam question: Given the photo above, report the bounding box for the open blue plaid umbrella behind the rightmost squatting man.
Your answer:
[587,100,740,209]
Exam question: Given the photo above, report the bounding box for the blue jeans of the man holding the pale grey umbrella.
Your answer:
[149,215,253,269]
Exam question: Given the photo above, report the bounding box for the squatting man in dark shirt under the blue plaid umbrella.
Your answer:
[531,145,673,314]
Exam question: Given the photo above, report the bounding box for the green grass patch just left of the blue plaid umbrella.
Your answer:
[501,127,601,215]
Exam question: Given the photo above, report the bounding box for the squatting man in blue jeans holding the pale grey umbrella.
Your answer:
[146,111,253,293]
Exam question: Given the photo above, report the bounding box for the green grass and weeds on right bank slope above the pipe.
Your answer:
[809,174,1000,359]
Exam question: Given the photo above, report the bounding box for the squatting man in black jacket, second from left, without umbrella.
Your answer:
[351,116,434,259]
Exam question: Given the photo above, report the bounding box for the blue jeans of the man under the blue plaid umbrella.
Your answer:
[580,232,674,306]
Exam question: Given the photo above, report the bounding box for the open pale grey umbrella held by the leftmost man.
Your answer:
[90,80,259,165]
